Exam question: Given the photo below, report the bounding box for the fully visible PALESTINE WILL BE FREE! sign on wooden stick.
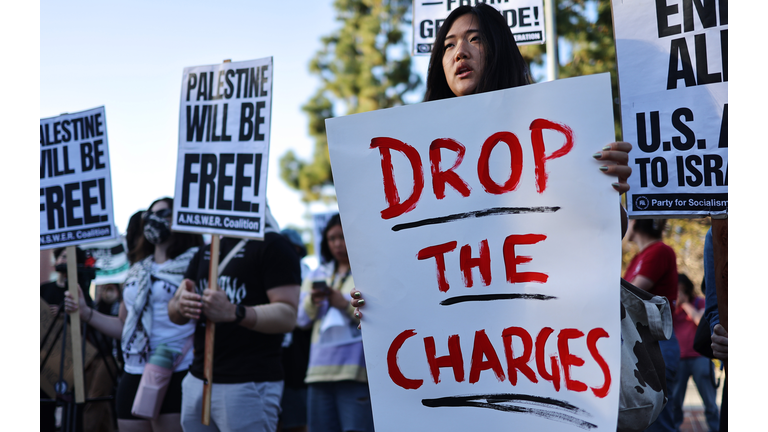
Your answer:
[172,57,273,238]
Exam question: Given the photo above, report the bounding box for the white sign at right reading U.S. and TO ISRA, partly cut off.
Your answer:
[613,0,728,217]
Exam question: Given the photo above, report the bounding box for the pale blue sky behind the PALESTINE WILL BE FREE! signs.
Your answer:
[40,1,366,236]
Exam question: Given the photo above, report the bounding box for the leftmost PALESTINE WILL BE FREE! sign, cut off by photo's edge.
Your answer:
[40,107,117,249]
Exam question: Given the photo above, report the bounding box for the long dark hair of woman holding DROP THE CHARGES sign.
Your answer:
[424,3,531,102]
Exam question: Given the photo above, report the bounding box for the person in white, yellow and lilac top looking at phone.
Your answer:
[298,214,373,432]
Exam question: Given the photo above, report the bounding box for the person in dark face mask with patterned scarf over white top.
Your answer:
[65,198,204,432]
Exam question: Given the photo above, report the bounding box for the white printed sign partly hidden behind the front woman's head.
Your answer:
[413,0,544,55]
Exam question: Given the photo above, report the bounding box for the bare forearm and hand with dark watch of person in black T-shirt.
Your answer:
[203,285,300,334]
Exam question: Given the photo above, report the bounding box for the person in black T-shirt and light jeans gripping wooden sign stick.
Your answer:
[168,209,301,432]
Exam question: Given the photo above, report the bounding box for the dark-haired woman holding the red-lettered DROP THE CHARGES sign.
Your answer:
[352,3,632,318]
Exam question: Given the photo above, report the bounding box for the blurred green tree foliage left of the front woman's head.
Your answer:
[280,0,420,202]
